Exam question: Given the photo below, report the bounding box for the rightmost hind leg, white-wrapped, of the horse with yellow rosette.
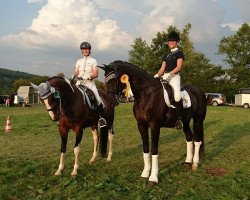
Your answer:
[192,119,204,171]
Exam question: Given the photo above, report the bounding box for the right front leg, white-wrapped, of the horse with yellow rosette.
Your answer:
[149,126,160,186]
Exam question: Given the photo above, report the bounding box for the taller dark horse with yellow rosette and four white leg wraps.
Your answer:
[100,61,207,185]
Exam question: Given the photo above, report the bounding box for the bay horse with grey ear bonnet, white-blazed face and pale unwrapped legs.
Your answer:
[31,77,114,176]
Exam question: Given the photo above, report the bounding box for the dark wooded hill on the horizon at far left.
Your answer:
[0,68,36,94]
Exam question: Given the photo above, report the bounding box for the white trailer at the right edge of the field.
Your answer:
[235,88,250,108]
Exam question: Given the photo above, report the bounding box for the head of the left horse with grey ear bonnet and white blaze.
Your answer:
[30,77,74,121]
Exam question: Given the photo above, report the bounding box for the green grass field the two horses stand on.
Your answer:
[0,103,250,200]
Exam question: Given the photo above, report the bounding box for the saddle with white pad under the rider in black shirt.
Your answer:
[161,80,191,108]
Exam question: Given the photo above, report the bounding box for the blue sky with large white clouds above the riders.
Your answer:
[0,0,250,78]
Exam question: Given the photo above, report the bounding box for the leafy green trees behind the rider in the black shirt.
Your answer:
[129,23,250,102]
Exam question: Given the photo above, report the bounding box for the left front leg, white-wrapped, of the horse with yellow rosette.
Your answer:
[137,123,151,178]
